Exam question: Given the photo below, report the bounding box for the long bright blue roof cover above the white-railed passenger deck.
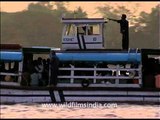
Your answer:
[56,52,141,63]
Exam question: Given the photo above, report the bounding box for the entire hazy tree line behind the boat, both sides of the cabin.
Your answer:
[0,2,160,48]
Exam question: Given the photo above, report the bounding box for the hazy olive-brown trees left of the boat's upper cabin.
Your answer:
[1,2,87,47]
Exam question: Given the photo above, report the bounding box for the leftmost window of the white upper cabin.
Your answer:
[65,24,76,36]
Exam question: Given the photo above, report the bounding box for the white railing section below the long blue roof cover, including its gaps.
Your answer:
[58,65,142,87]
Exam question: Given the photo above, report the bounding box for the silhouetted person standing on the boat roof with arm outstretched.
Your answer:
[108,14,129,50]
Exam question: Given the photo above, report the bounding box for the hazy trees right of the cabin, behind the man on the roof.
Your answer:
[97,5,160,48]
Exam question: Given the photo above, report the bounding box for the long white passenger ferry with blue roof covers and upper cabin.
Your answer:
[0,18,160,104]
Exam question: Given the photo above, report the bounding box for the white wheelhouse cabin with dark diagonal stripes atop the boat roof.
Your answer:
[62,18,106,50]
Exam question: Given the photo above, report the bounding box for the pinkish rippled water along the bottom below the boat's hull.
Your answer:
[0,103,160,119]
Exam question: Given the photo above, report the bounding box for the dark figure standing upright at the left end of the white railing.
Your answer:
[49,51,59,86]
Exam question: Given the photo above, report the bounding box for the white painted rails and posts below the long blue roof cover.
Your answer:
[58,65,142,87]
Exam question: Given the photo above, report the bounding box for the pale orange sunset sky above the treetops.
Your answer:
[0,1,160,17]
